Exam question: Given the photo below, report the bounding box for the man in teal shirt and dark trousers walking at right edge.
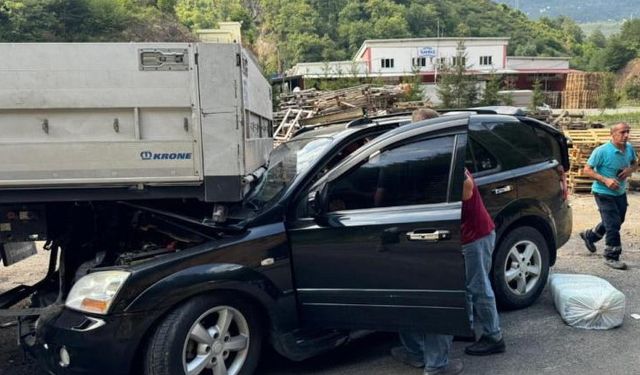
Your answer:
[580,122,637,270]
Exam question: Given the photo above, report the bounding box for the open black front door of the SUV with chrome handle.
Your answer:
[287,118,470,335]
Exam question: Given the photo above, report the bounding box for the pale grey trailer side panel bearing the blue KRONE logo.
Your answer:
[0,43,202,188]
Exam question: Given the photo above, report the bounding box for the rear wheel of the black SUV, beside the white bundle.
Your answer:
[491,227,549,310]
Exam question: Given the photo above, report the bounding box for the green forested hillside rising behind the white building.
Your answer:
[0,0,640,73]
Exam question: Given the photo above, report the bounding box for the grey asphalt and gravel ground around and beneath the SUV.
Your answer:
[0,193,640,375]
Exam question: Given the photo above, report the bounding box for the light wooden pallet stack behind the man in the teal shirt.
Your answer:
[564,129,640,193]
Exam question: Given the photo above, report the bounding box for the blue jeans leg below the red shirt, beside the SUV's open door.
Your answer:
[462,231,502,340]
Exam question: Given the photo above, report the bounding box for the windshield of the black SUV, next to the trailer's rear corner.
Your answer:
[245,137,331,210]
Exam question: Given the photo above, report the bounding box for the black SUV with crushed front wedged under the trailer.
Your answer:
[23,111,572,375]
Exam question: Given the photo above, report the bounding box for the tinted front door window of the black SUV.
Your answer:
[327,136,454,211]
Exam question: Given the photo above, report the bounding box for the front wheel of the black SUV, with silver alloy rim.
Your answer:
[144,296,262,375]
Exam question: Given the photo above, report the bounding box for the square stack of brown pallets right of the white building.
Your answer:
[562,72,603,109]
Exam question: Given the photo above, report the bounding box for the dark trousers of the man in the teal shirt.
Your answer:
[587,193,629,259]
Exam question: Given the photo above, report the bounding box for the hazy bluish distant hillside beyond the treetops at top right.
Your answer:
[496,0,640,23]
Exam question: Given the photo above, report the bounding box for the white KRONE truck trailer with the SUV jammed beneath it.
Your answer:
[0,43,273,306]
